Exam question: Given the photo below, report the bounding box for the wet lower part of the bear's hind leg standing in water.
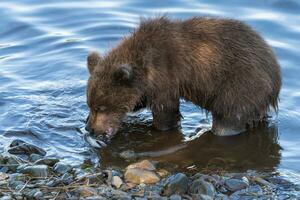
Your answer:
[212,115,246,136]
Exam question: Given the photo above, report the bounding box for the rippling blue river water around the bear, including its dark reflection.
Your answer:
[0,0,300,183]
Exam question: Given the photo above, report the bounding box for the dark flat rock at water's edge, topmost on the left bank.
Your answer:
[8,140,46,156]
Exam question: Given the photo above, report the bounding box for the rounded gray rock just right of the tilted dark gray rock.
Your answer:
[190,179,216,197]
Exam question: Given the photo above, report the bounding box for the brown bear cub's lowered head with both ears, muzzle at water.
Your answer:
[86,53,141,138]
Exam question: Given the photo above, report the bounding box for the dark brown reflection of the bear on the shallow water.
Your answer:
[99,124,281,171]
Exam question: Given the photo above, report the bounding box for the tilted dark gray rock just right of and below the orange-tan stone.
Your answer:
[162,173,188,196]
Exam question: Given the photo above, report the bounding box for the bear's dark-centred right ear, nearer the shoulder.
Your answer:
[113,64,133,84]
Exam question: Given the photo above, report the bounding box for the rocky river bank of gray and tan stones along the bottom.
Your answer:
[0,140,300,200]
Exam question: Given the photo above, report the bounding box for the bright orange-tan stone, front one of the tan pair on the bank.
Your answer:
[124,168,160,184]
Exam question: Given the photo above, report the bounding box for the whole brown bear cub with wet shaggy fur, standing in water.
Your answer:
[86,17,281,138]
